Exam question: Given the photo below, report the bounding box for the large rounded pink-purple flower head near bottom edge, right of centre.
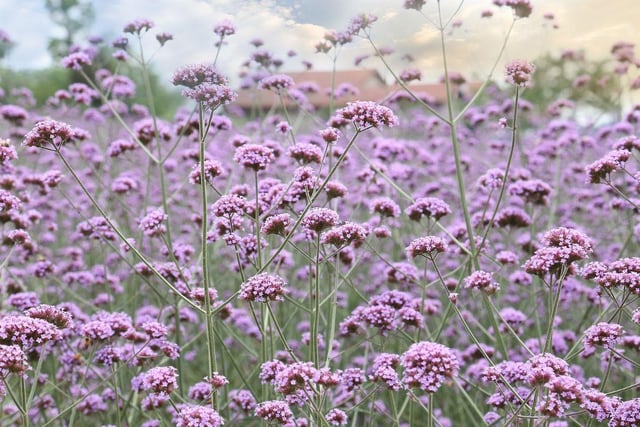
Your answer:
[400,341,459,393]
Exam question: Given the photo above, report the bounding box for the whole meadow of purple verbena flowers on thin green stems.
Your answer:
[0,0,640,427]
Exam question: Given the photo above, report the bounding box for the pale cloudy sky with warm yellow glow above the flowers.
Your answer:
[0,0,640,88]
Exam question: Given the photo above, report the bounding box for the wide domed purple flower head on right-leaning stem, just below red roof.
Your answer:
[327,101,399,131]
